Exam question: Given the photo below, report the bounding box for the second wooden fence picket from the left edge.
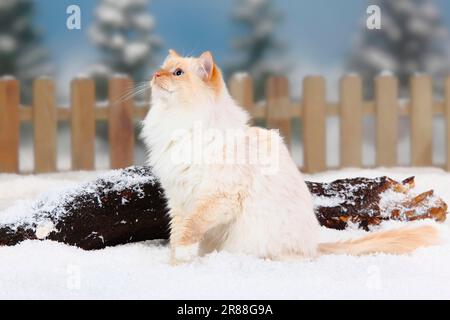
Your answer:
[32,78,57,173]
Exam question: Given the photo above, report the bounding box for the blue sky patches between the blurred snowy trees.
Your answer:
[35,0,450,99]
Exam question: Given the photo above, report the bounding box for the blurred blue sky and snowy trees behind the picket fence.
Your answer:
[0,0,450,168]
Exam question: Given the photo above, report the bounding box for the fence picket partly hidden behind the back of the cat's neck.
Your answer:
[229,73,255,122]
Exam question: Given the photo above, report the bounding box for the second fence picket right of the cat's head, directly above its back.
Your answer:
[266,76,291,148]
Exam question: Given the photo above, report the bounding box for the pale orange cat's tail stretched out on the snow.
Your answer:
[319,225,439,256]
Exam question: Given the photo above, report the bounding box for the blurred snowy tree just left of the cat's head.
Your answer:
[90,0,161,85]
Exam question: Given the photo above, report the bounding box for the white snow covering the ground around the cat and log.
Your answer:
[0,168,450,299]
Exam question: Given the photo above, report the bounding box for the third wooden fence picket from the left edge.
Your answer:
[70,79,95,170]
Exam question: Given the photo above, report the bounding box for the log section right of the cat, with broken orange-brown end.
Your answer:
[306,177,447,231]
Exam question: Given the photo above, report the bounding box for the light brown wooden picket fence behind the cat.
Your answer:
[0,74,450,173]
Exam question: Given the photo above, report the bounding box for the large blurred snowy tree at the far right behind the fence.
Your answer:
[348,0,450,96]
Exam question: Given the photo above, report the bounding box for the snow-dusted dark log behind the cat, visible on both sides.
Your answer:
[0,166,447,250]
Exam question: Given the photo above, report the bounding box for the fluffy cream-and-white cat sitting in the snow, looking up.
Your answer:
[142,50,438,264]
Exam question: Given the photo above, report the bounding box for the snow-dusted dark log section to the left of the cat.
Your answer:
[0,167,169,250]
